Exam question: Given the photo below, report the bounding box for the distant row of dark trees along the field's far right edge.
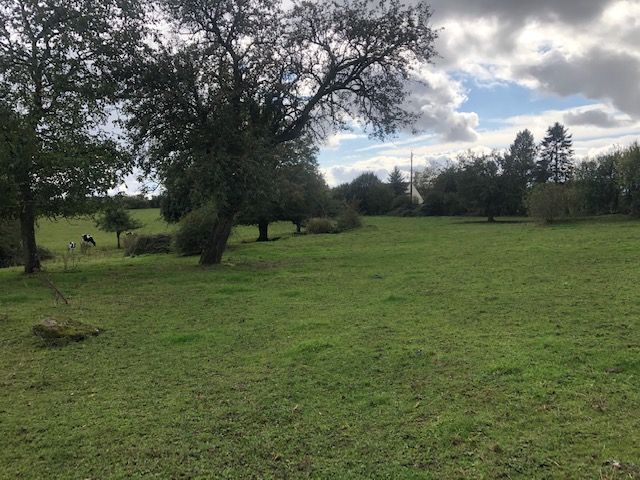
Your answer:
[333,123,640,221]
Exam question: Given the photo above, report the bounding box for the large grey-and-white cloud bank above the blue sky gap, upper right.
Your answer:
[420,0,640,119]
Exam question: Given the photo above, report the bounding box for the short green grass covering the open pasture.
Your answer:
[0,211,640,479]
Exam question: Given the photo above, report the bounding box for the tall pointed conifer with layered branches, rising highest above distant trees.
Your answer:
[536,122,574,183]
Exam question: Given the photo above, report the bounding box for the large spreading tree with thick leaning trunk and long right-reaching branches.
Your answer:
[127,0,436,264]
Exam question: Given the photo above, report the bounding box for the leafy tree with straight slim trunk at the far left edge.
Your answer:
[0,0,138,273]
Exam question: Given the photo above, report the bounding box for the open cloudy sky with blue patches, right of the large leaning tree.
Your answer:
[319,0,640,185]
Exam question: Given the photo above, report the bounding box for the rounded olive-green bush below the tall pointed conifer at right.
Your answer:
[527,183,582,223]
